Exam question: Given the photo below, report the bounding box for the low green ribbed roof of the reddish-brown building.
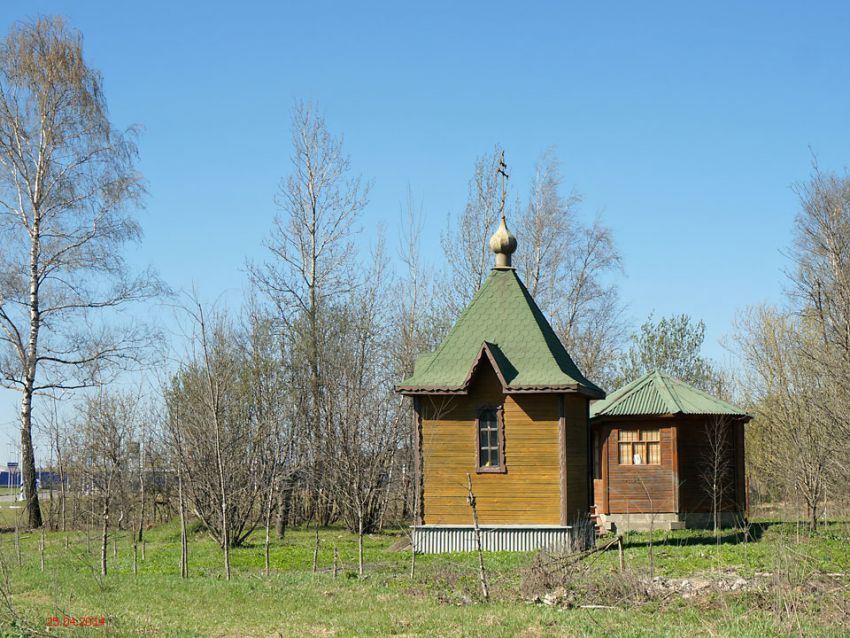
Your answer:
[590,371,748,417]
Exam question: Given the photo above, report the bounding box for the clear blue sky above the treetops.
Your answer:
[0,0,850,462]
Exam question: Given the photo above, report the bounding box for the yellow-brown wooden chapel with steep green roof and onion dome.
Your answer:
[396,214,605,553]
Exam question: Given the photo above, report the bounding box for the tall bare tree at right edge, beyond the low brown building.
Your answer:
[724,166,850,529]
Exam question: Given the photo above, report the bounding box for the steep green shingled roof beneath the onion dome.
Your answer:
[396,269,605,398]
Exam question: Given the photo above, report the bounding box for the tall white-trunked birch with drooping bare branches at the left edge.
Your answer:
[0,18,160,527]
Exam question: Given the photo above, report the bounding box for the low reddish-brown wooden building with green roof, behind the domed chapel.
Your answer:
[590,372,751,530]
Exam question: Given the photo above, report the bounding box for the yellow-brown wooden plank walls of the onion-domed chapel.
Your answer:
[419,365,587,525]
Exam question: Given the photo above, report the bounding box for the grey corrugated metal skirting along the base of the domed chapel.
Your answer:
[413,525,576,554]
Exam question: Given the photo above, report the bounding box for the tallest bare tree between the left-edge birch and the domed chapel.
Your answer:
[249,104,368,524]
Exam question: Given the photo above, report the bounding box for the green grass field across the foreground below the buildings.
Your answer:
[0,523,850,638]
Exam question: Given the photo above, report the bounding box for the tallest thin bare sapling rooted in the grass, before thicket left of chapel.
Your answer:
[167,302,274,578]
